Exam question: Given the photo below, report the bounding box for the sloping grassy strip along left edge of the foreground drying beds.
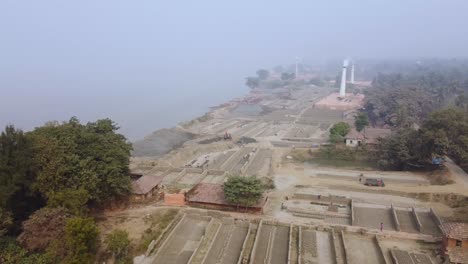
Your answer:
[136,209,179,255]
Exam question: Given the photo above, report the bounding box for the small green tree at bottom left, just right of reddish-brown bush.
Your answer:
[65,217,99,264]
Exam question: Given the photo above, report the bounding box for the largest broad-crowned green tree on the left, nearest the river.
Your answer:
[31,118,131,207]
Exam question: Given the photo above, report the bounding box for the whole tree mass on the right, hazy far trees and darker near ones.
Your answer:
[364,60,468,170]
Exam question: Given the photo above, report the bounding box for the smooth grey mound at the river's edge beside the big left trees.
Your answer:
[132,128,195,157]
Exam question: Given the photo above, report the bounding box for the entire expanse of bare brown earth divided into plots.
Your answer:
[118,85,468,264]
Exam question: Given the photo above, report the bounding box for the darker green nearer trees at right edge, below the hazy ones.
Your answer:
[378,108,468,171]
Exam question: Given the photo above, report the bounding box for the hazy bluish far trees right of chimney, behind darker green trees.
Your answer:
[365,63,468,128]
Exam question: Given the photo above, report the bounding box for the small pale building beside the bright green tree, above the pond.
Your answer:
[345,128,391,147]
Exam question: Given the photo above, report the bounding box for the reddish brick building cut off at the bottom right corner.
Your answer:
[441,223,468,263]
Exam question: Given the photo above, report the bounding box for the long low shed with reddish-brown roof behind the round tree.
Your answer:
[186,183,266,213]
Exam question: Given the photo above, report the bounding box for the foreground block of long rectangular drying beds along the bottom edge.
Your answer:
[123,209,440,264]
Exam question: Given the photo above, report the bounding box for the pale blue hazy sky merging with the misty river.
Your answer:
[0,0,468,139]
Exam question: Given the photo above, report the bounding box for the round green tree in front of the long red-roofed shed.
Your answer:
[224,176,264,209]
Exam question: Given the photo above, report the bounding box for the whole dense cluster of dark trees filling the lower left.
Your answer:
[0,118,131,263]
